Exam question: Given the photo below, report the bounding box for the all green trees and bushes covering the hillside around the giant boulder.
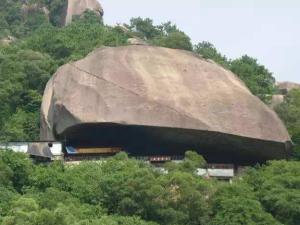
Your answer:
[0,0,300,225]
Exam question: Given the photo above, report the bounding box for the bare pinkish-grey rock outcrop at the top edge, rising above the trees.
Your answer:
[65,0,104,25]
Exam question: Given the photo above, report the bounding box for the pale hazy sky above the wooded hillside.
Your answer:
[99,0,300,83]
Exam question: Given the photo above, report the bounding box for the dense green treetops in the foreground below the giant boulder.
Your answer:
[0,151,300,225]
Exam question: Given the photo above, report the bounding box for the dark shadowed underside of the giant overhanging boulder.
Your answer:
[56,123,292,165]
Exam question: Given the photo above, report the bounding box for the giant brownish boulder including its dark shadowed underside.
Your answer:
[41,46,291,164]
